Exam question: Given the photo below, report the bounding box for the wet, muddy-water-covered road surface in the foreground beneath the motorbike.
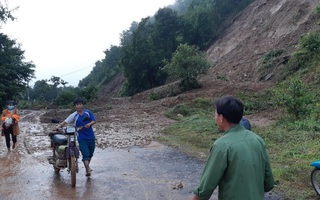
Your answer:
[0,111,279,200]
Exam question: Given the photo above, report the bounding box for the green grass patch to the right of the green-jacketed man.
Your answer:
[253,123,320,199]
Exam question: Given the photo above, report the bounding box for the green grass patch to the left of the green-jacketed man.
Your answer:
[158,98,221,161]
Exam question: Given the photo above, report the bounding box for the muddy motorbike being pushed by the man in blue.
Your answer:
[48,123,79,187]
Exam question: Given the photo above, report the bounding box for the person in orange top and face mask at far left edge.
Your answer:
[1,101,20,151]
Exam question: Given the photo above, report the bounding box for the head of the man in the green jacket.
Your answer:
[214,96,244,130]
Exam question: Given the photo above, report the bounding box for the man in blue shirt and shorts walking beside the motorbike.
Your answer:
[57,98,96,177]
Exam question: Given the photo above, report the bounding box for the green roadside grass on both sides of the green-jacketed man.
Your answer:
[158,99,320,199]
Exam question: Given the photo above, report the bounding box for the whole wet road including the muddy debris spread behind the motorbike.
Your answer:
[0,99,280,200]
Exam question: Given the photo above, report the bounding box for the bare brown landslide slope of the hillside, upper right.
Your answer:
[101,0,320,125]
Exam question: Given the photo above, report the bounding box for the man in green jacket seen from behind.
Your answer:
[193,96,274,200]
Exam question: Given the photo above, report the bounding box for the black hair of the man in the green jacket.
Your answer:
[214,96,244,124]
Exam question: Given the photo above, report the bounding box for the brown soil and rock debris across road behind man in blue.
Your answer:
[41,98,174,148]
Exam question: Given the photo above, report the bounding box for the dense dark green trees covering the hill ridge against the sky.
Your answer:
[79,0,253,95]
